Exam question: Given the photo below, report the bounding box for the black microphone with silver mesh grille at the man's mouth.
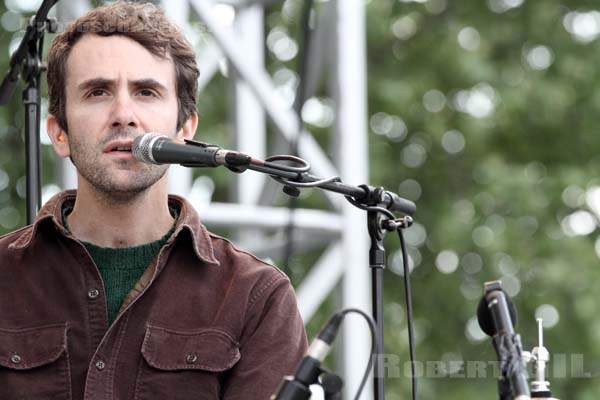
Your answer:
[131,133,252,168]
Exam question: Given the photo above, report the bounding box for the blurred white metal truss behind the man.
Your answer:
[57,0,373,399]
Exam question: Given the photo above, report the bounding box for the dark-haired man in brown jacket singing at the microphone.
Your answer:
[0,3,306,400]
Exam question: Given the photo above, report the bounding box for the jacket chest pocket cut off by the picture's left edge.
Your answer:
[0,324,71,400]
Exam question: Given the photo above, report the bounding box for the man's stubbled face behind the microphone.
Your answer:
[54,34,185,197]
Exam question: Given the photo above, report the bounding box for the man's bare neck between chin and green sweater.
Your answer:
[67,179,174,247]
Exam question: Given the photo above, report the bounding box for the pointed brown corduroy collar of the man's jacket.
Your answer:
[9,190,220,266]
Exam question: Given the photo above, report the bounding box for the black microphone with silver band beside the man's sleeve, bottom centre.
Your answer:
[271,313,344,400]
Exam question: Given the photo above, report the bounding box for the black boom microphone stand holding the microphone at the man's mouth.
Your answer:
[181,145,416,400]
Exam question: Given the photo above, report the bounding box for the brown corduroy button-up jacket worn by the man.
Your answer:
[0,191,306,400]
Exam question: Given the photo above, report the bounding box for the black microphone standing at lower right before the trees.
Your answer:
[477,281,531,400]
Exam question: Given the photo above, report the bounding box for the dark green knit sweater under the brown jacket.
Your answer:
[62,207,179,325]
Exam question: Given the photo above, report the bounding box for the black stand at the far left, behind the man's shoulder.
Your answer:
[0,0,58,225]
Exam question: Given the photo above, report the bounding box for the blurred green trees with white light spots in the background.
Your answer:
[0,0,600,400]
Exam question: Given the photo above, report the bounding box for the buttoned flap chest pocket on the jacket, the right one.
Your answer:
[135,325,240,400]
